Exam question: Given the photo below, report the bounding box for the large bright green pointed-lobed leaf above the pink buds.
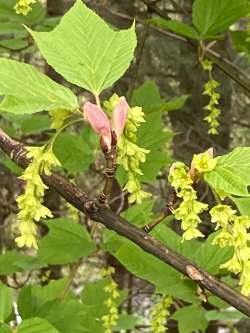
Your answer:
[30,0,136,94]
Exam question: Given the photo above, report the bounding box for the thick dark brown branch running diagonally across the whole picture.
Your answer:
[0,129,250,317]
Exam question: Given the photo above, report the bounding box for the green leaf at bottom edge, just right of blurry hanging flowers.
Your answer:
[171,305,208,333]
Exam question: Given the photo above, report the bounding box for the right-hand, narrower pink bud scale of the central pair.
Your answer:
[111,97,129,139]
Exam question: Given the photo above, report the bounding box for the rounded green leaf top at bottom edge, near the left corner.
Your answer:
[16,318,60,333]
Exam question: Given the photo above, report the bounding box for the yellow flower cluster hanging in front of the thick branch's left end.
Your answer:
[16,147,60,248]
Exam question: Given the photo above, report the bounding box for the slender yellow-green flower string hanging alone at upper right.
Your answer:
[201,60,221,135]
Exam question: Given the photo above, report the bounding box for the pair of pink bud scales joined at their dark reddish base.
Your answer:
[83,97,129,152]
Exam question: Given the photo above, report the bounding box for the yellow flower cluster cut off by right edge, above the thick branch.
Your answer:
[210,205,250,296]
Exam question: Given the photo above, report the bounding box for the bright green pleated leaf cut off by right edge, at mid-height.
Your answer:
[205,147,250,197]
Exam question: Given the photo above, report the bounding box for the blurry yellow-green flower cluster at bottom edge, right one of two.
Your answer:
[150,296,173,333]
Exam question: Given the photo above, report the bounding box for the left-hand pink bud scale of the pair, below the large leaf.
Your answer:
[83,102,111,149]
